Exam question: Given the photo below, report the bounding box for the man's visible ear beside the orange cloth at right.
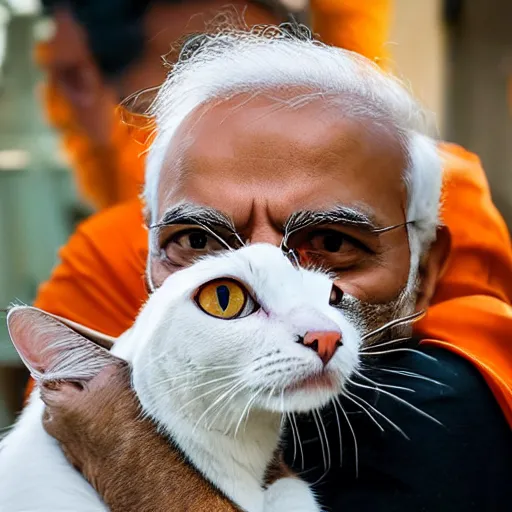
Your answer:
[416,226,451,311]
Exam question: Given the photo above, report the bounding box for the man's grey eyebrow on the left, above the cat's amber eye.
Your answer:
[150,203,236,233]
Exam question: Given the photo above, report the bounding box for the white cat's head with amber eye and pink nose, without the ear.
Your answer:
[126,244,361,427]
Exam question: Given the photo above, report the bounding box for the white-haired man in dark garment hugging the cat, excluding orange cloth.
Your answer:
[38,29,512,511]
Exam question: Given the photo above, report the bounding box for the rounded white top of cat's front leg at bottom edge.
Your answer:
[263,477,321,512]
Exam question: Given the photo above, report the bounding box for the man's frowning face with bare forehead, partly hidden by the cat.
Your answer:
[151,95,416,316]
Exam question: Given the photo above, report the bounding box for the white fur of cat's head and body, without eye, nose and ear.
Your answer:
[0,245,360,512]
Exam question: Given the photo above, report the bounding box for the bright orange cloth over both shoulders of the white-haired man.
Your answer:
[35,145,512,425]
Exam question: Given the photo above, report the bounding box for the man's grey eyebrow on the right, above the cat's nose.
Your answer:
[284,206,382,237]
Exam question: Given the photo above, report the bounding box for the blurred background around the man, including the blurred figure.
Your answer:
[0,0,512,428]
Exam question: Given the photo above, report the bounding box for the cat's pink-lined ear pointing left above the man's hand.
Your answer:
[7,306,121,382]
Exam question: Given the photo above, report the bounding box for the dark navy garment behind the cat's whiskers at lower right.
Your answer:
[286,342,512,512]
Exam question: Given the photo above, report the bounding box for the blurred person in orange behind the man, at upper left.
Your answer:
[36,0,294,210]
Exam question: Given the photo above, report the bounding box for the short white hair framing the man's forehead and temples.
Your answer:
[145,27,441,278]
